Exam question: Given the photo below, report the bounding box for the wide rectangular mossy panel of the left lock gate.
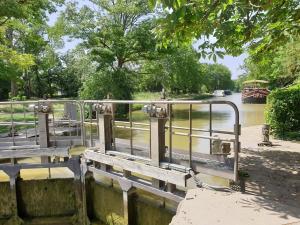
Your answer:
[18,179,76,217]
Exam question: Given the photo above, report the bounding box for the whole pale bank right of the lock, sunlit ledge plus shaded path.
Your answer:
[171,126,300,225]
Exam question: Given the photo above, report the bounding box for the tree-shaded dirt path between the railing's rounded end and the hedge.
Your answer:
[240,126,300,207]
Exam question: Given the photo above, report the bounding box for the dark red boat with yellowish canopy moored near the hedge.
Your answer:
[242,80,270,104]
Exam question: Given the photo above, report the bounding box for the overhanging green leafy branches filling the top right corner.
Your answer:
[149,0,300,58]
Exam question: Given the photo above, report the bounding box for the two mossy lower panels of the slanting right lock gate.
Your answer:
[87,180,175,225]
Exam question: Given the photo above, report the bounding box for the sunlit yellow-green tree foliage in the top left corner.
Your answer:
[0,0,63,96]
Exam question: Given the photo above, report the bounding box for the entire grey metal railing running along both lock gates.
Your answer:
[0,99,240,180]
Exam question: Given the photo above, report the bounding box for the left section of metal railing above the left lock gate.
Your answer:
[0,100,83,146]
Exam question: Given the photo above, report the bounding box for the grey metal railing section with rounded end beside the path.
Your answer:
[83,100,240,180]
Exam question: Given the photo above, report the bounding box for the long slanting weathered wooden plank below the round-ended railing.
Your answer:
[84,150,189,187]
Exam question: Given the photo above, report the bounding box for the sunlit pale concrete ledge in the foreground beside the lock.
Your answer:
[170,189,300,225]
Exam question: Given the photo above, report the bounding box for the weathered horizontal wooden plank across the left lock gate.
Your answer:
[0,148,69,159]
